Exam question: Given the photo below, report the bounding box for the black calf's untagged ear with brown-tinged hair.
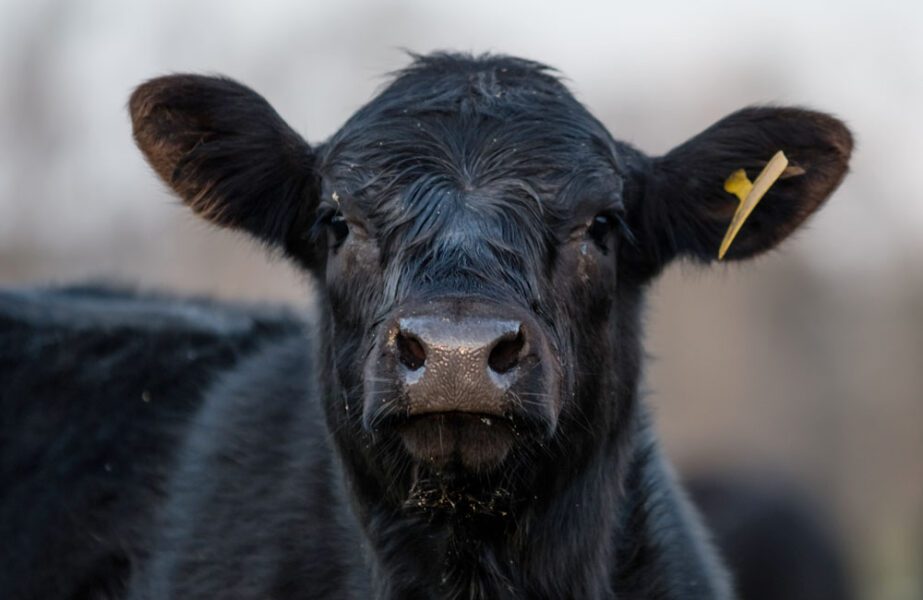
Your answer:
[129,75,319,266]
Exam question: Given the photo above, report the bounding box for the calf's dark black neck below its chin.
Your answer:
[328,382,637,600]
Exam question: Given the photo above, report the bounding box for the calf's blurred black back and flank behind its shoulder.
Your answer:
[0,286,301,600]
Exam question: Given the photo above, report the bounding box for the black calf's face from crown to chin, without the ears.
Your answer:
[317,61,625,482]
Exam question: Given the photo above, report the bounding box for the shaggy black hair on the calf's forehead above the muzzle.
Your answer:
[320,56,621,302]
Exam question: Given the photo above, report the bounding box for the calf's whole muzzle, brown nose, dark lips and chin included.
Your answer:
[364,299,560,471]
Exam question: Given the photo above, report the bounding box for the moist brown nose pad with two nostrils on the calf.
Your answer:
[394,316,529,415]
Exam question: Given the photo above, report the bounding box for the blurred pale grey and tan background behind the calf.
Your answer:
[0,0,923,600]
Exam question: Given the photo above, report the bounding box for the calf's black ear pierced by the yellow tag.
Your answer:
[623,108,853,275]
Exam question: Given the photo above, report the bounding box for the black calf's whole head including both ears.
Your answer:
[131,55,851,508]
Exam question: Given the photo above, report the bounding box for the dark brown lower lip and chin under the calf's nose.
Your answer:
[398,411,515,473]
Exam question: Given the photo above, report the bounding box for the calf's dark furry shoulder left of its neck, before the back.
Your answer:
[131,330,363,599]
